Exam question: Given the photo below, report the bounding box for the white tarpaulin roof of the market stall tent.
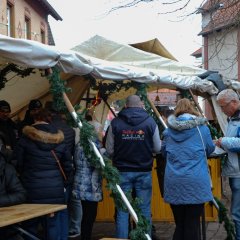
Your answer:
[0,35,218,95]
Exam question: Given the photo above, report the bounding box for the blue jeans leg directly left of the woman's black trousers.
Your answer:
[69,196,82,234]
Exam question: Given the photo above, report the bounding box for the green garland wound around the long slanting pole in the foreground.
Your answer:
[48,68,150,240]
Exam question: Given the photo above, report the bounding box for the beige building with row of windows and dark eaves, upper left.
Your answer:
[0,0,62,45]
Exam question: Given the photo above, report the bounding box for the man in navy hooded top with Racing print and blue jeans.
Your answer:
[106,95,161,238]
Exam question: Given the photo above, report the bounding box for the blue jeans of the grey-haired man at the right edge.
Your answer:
[229,178,240,240]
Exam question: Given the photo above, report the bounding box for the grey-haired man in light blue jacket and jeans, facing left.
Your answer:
[216,89,240,240]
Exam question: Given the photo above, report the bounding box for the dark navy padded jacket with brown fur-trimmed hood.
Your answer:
[13,124,72,203]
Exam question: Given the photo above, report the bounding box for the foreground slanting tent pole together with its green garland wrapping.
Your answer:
[49,68,151,240]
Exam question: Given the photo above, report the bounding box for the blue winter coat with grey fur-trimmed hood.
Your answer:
[162,114,215,205]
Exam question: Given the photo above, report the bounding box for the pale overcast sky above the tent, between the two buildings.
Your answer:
[48,0,203,64]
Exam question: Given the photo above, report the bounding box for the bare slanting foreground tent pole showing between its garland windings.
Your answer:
[63,92,151,240]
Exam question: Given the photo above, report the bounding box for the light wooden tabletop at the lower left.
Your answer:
[0,204,67,227]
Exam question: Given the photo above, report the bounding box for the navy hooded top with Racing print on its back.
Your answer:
[111,107,157,172]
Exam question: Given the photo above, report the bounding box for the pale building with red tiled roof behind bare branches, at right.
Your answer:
[200,0,240,83]
